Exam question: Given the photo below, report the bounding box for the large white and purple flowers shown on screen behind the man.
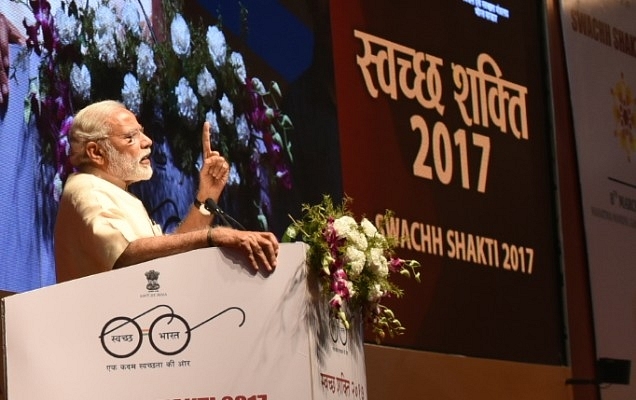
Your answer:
[19,0,292,229]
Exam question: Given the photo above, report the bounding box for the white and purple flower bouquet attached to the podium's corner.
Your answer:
[283,196,420,342]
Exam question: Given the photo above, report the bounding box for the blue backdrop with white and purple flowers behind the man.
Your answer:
[0,0,332,292]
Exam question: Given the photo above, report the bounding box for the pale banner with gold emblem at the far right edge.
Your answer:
[561,0,636,400]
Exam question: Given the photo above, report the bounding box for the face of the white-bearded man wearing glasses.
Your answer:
[104,109,152,185]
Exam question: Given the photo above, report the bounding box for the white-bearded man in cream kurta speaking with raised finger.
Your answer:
[55,100,278,282]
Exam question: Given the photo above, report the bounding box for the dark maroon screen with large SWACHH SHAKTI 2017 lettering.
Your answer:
[331,0,566,365]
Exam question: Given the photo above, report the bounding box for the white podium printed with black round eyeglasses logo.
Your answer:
[2,243,366,400]
